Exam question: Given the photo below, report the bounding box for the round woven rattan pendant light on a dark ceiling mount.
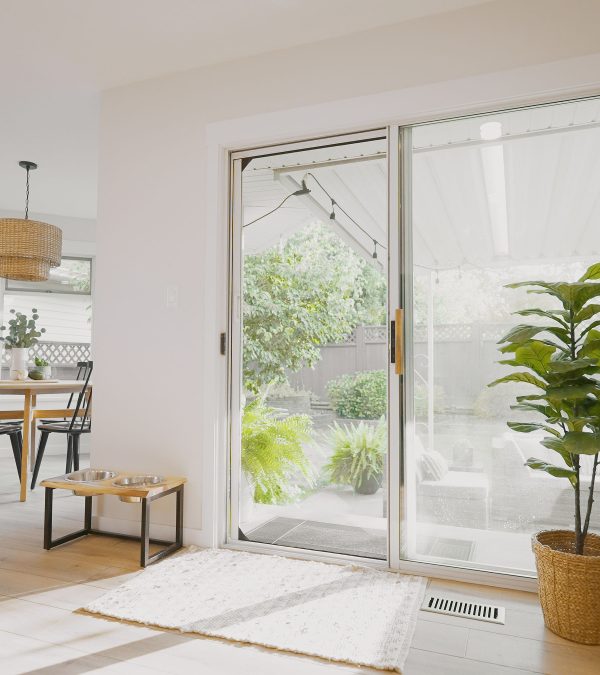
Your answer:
[0,162,62,281]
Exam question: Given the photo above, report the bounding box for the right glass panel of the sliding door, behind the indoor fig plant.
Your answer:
[404,99,600,574]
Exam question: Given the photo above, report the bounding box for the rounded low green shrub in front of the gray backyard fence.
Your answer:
[327,370,387,420]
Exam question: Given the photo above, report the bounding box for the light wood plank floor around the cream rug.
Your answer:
[0,451,600,675]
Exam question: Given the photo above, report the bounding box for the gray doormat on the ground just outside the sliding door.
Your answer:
[244,518,387,560]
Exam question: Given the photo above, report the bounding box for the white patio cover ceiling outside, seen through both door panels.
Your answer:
[244,99,600,270]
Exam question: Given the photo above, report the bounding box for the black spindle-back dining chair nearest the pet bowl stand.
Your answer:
[31,361,94,490]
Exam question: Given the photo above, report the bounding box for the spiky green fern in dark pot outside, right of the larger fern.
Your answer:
[325,418,387,495]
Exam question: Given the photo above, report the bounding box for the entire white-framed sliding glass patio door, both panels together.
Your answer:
[229,99,600,576]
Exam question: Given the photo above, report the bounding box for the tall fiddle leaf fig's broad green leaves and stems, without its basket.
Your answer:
[488,263,600,555]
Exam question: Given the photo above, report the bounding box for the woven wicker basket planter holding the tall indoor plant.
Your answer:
[532,530,600,645]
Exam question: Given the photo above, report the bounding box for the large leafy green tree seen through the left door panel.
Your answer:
[243,225,386,393]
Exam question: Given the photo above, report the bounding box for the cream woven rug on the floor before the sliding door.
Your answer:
[84,550,426,672]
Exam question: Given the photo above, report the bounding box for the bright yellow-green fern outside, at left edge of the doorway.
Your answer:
[242,397,313,504]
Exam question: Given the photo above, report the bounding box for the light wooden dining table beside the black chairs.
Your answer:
[0,379,92,502]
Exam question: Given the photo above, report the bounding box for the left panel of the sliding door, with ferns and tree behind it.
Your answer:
[230,132,397,560]
